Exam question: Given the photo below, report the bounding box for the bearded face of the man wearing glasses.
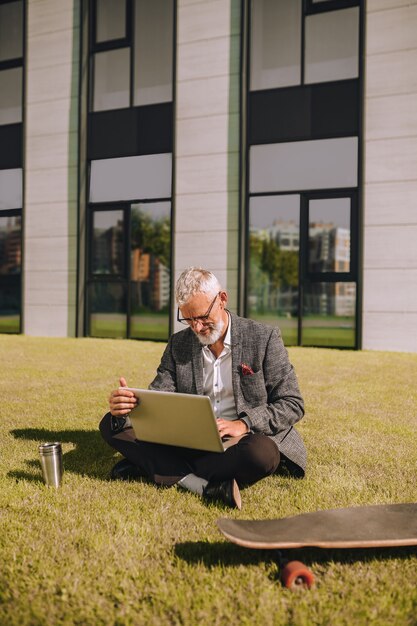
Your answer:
[180,291,227,345]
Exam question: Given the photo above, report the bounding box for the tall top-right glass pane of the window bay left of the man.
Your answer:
[134,0,174,105]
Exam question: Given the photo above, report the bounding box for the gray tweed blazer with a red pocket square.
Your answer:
[149,313,307,475]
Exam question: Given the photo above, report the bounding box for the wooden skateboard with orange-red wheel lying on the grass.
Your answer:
[217,503,417,590]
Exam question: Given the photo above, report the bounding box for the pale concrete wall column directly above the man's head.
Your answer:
[174,0,240,322]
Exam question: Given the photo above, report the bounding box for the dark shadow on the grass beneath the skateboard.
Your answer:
[175,541,415,569]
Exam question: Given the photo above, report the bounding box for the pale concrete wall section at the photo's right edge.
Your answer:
[363,0,417,352]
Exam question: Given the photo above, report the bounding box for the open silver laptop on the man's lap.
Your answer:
[124,387,228,452]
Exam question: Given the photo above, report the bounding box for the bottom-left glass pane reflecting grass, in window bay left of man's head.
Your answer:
[89,281,127,338]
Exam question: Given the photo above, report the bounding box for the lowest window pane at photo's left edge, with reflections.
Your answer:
[0,216,22,333]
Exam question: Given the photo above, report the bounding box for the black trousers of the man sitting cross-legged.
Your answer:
[100,413,280,486]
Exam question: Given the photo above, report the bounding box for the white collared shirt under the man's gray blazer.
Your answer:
[202,313,238,420]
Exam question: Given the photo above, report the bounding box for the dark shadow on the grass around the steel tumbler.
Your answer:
[8,428,114,482]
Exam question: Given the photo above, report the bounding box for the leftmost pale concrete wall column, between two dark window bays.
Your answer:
[23,0,79,336]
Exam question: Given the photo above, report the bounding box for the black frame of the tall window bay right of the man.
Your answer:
[240,0,364,349]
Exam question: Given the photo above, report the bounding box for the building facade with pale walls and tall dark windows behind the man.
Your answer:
[0,0,417,352]
